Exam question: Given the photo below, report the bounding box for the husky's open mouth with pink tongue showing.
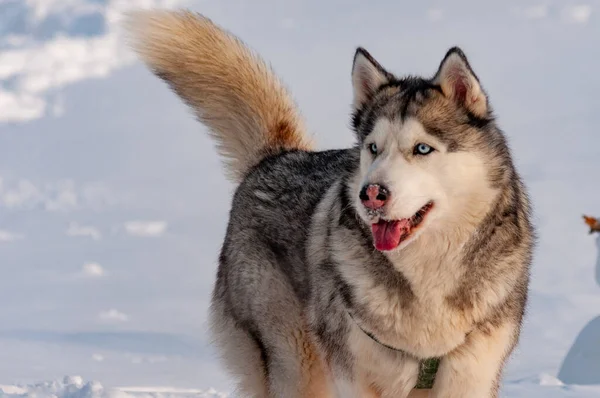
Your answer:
[371,201,433,251]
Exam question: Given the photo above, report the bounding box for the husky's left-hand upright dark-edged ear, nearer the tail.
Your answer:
[352,47,393,109]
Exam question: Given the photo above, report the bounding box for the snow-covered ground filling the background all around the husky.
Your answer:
[0,0,600,398]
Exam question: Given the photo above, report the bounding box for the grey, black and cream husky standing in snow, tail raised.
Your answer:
[128,11,535,398]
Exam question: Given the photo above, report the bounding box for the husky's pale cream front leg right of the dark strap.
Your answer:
[430,323,517,398]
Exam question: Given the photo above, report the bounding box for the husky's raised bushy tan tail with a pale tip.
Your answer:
[125,10,312,181]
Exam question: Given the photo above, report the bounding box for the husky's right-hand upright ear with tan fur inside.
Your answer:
[433,47,488,117]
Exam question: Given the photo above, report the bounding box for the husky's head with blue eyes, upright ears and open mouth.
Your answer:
[350,48,512,251]
